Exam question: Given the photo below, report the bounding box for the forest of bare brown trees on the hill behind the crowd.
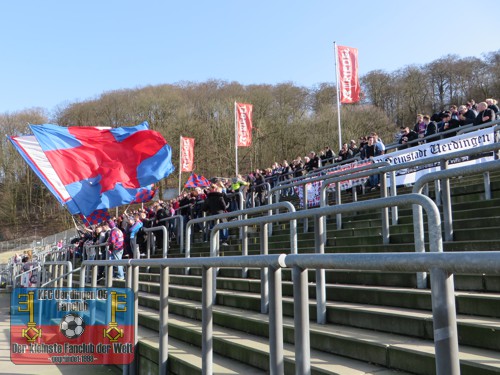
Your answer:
[0,50,500,240]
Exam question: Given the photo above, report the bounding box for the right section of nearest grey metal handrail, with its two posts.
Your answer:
[285,251,500,375]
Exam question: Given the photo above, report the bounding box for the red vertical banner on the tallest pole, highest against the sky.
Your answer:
[337,46,361,104]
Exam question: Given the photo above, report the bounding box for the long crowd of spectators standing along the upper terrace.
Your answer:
[44,99,500,279]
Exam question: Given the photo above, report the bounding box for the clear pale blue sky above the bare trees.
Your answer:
[0,0,500,113]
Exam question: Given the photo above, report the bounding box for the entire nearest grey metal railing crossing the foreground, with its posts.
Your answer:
[82,248,500,375]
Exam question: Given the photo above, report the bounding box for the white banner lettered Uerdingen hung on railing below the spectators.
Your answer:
[373,128,495,185]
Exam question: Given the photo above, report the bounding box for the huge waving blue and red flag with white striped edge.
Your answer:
[10,122,174,216]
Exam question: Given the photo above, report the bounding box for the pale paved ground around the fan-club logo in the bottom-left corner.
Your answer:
[0,290,122,375]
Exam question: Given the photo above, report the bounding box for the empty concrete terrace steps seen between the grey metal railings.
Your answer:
[140,175,500,375]
